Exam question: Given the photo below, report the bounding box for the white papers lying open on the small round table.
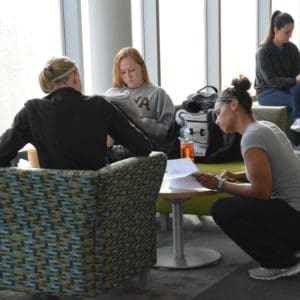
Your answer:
[167,158,203,190]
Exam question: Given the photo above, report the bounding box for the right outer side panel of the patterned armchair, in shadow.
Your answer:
[95,152,166,292]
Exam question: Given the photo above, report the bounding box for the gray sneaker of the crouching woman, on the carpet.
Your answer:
[249,262,300,280]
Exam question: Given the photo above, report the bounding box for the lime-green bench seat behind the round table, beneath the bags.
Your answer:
[156,161,244,216]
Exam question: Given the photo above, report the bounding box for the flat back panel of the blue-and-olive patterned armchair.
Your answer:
[0,168,98,294]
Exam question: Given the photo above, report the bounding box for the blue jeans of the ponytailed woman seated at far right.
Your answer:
[258,84,300,145]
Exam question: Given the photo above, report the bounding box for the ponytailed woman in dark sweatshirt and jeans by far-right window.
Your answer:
[254,10,300,145]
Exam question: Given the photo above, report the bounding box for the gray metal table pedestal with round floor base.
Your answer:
[155,199,221,269]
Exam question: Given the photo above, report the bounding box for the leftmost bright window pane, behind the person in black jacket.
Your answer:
[0,0,63,133]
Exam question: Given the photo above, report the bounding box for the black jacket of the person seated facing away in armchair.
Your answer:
[0,88,152,170]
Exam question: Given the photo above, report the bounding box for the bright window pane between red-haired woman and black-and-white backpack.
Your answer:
[159,0,206,104]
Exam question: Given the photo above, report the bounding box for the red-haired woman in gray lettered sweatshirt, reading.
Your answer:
[105,47,175,159]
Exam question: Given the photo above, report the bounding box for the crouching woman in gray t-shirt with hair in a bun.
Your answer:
[195,76,300,280]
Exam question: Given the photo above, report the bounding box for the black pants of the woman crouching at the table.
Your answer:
[212,197,300,268]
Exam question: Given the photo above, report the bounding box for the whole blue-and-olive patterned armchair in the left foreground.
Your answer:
[0,152,166,296]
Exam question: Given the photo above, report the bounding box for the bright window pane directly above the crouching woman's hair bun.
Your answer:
[221,0,257,92]
